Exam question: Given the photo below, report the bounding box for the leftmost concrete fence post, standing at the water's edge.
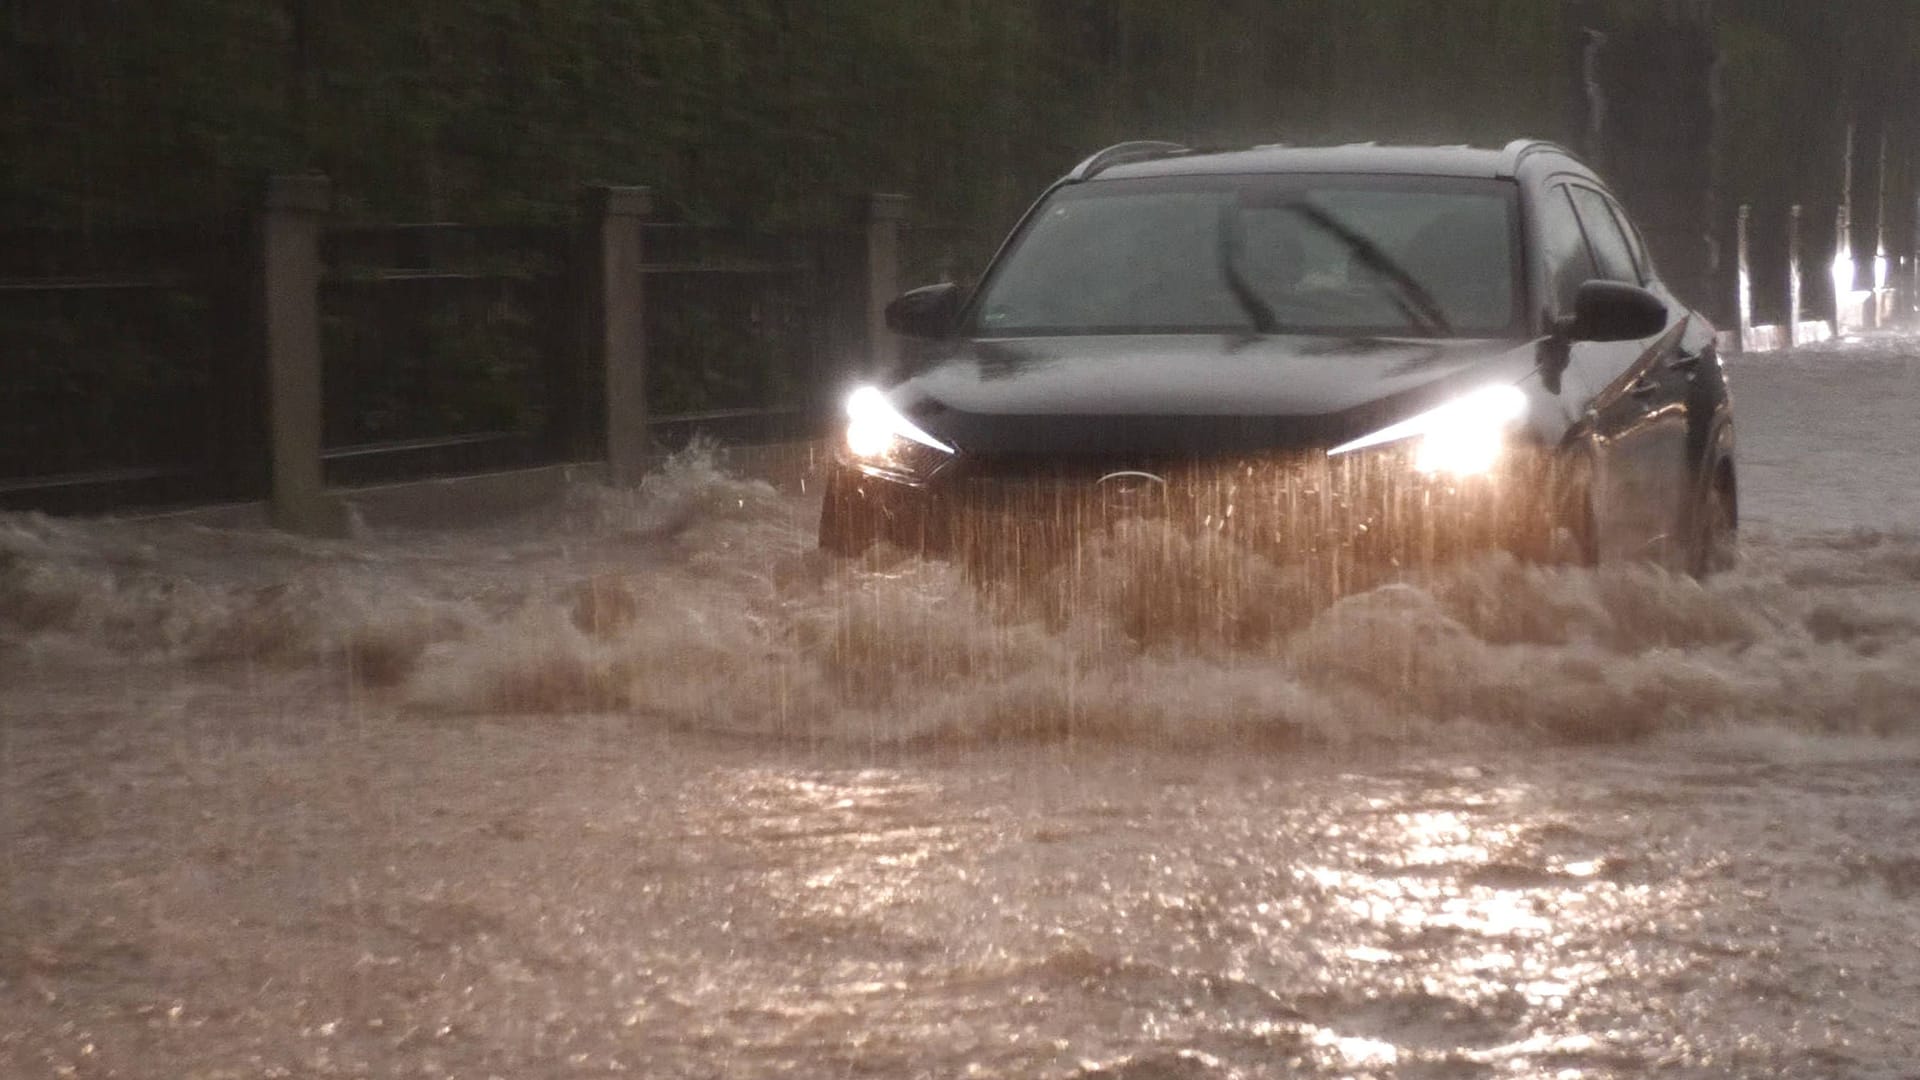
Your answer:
[259,177,348,536]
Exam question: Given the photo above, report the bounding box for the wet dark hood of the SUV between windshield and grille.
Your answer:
[889,334,1538,457]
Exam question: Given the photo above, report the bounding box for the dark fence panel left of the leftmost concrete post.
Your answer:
[0,223,265,511]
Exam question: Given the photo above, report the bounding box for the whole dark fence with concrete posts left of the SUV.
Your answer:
[0,177,933,532]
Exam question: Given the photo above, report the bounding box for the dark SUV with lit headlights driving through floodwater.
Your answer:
[820,142,1738,573]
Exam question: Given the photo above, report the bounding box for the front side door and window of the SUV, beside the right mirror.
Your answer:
[1567,183,1690,559]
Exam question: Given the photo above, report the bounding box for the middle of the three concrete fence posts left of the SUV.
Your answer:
[588,186,653,484]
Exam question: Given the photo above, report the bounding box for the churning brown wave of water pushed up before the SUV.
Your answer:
[0,455,1920,744]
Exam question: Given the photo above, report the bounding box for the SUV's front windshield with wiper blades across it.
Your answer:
[972,175,1521,336]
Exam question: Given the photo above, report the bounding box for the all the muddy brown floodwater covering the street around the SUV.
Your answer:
[0,338,1920,1080]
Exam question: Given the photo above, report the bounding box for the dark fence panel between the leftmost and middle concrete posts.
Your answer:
[319,225,584,484]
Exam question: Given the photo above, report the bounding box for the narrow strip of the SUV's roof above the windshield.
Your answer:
[1068,140,1588,181]
